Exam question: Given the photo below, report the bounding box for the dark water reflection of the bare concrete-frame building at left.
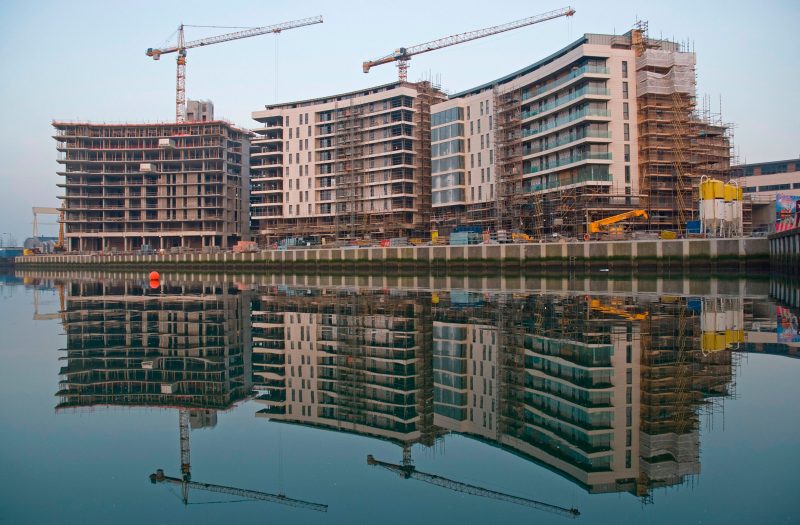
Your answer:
[58,281,251,409]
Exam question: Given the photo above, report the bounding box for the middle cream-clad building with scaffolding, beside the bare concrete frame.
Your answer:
[250,82,444,242]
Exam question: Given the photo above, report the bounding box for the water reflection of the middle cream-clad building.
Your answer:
[252,288,432,443]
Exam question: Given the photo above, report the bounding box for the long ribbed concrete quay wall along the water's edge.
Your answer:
[15,238,770,272]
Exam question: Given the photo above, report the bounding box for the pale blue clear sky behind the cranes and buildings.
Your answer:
[0,0,800,244]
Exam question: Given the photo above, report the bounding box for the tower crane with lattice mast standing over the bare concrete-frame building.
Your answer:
[146,16,322,122]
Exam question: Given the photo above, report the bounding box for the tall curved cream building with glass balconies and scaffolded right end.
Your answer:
[432,24,731,237]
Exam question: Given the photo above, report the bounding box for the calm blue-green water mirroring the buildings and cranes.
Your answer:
[0,272,800,524]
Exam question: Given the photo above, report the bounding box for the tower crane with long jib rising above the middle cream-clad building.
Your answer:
[363,6,575,82]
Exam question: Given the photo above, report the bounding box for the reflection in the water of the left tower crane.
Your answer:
[150,408,328,512]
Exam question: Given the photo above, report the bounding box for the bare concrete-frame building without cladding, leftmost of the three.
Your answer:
[53,113,249,251]
